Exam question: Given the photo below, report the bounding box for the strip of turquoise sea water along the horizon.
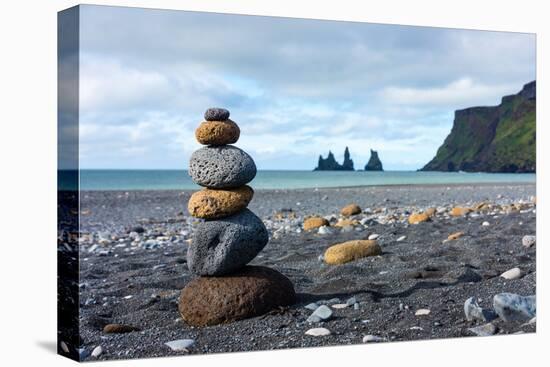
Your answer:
[58,170,535,190]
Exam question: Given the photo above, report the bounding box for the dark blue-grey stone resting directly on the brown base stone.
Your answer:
[187,209,269,275]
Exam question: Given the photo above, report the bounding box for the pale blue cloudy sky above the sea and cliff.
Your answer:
[75,6,535,170]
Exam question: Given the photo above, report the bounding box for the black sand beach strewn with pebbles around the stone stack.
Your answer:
[68,184,536,360]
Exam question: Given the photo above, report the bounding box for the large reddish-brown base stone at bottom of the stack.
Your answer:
[178,266,296,326]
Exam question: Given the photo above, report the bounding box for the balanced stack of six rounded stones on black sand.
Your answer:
[178,108,296,326]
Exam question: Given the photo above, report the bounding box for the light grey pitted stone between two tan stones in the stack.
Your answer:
[189,145,256,189]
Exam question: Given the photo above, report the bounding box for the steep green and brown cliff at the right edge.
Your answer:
[422,81,536,172]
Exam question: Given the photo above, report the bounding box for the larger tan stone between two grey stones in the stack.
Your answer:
[187,185,254,219]
